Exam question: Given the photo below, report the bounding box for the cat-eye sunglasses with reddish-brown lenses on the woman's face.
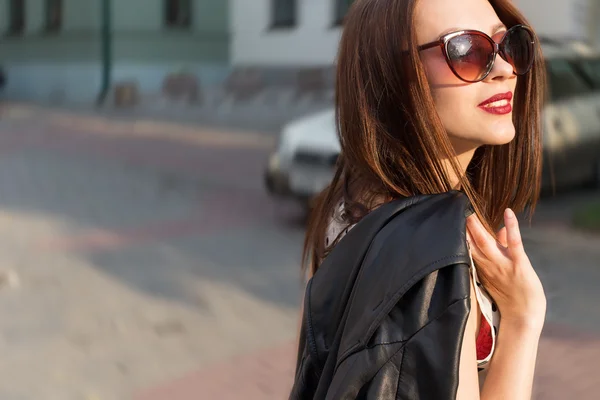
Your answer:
[418,25,535,83]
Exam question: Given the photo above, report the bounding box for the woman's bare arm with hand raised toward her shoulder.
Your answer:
[460,209,546,400]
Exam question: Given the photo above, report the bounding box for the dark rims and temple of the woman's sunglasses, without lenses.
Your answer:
[418,25,536,83]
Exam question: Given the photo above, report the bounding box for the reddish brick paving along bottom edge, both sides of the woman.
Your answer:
[135,324,600,400]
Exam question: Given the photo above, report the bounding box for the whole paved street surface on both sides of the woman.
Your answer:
[0,104,600,400]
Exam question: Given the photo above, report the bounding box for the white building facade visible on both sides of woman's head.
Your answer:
[231,0,600,67]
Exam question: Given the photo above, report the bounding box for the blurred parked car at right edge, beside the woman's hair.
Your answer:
[542,43,600,192]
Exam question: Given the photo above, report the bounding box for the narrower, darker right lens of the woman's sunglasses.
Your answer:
[501,27,535,75]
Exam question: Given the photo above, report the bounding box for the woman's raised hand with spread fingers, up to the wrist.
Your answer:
[467,209,546,332]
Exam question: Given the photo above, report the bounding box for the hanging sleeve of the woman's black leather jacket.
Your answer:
[326,264,470,400]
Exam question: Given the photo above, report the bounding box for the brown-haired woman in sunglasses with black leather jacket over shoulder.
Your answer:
[291,0,546,400]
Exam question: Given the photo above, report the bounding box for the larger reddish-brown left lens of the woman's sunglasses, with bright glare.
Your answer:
[446,33,494,82]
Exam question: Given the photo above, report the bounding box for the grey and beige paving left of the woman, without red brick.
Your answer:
[0,101,300,400]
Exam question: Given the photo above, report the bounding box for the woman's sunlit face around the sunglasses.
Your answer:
[416,0,517,155]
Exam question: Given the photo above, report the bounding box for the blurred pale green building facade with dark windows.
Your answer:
[0,0,230,102]
